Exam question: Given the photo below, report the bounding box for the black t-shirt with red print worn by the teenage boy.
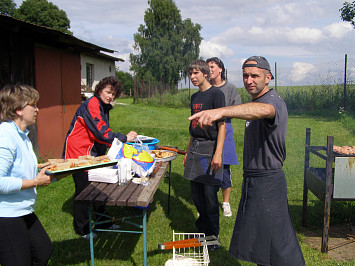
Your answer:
[189,86,226,140]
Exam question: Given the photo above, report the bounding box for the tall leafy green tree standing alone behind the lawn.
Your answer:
[130,0,202,87]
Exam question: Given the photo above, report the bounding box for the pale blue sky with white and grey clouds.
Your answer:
[14,0,355,85]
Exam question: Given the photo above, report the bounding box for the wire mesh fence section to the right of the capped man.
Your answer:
[275,55,355,111]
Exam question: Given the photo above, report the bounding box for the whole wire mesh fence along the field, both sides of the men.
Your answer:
[134,55,355,111]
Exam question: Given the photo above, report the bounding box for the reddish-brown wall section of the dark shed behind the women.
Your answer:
[34,45,81,159]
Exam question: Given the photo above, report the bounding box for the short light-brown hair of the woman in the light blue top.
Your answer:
[0,83,39,122]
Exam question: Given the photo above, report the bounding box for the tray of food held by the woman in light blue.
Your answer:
[38,155,118,175]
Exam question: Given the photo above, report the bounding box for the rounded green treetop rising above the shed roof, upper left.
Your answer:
[14,0,73,35]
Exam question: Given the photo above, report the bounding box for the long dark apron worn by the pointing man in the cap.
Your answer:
[229,169,305,266]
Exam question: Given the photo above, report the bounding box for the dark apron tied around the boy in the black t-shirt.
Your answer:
[184,139,223,185]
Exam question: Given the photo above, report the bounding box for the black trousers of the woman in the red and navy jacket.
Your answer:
[73,171,112,235]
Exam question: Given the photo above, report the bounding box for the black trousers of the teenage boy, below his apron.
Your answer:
[191,181,219,237]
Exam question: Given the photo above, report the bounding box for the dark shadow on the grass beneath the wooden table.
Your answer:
[55,194,156,265]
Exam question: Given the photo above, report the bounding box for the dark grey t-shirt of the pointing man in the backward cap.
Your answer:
[243,90,288,170]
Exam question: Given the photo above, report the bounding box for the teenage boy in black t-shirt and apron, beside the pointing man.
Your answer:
[183,60,226,250]
